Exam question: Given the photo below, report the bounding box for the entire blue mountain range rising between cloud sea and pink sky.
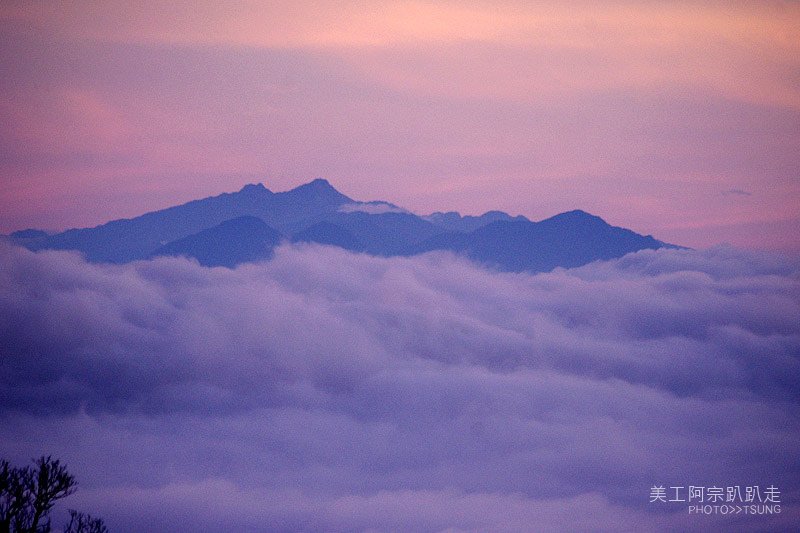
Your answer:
[8,179,673,272]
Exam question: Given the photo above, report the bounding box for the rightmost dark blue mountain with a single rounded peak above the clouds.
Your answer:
[410,211,664,272]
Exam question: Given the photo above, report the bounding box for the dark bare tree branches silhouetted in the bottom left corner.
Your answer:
[0,456,108,533]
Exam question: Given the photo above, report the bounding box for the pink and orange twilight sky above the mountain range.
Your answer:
[0,0,800,251]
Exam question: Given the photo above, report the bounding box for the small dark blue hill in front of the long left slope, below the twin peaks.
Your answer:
[150,216,281,268]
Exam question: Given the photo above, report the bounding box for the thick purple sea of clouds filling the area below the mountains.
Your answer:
[0,244,800,532]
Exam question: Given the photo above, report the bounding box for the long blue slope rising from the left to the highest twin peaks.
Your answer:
[28,179,352,263]
